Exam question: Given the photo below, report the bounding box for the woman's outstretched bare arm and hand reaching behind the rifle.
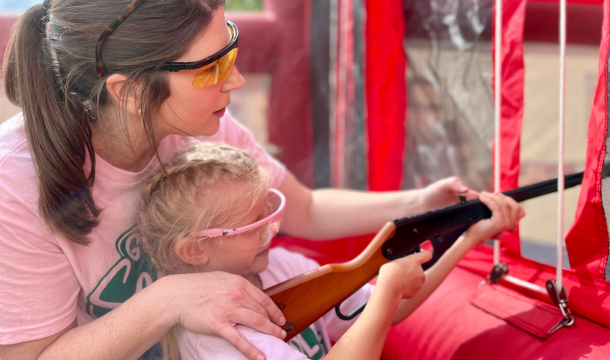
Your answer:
[279,172,478,240]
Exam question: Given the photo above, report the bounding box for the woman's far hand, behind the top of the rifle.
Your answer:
[411,176,479,215]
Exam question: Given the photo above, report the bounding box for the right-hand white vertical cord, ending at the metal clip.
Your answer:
[556,0,566,292]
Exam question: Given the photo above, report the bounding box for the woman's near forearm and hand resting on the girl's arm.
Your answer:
[0,273,286,360]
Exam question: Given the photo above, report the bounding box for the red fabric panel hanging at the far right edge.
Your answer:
[566,1,610,280]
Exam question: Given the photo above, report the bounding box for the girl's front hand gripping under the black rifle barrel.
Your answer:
[465,192,525,247]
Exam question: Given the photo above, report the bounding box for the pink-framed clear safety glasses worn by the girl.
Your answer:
[190,189,286,251]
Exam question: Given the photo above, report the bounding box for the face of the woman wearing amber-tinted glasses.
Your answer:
[157,7,244,138]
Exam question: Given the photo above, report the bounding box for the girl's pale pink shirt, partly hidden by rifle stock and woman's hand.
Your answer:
[174,248,374,360]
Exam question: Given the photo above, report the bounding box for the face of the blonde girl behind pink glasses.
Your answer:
[200,196,270,279]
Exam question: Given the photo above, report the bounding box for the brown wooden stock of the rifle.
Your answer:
[265,222,396,341]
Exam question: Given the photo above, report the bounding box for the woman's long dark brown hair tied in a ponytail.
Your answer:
[4,0,224,245]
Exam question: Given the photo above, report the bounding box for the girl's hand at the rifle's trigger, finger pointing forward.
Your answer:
[376,251,432,299]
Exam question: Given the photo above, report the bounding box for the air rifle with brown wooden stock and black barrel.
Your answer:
[265,173,583,341]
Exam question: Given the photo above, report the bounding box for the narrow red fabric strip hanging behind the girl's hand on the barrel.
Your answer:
[491,0,526,254]
